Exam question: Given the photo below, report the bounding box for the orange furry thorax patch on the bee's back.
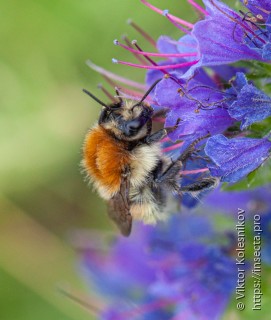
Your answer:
[83,126,131,193]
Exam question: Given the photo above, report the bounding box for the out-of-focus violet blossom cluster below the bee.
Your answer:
[81,187,271,320]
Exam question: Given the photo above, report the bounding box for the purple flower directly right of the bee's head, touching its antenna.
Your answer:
[154,79,233,141]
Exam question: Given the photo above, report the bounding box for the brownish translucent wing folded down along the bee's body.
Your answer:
[108,176,132,237]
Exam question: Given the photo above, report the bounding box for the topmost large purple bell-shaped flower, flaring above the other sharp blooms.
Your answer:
[182,0,262,77]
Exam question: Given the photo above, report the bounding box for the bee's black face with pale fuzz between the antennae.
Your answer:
[99,100,153,139]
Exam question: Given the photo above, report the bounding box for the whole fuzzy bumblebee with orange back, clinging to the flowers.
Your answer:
[81,79,217,236]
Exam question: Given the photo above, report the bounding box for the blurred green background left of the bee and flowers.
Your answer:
[0,0,196,320]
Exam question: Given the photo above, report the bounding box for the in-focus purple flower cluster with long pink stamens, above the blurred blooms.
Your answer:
[87,0,271,192]
